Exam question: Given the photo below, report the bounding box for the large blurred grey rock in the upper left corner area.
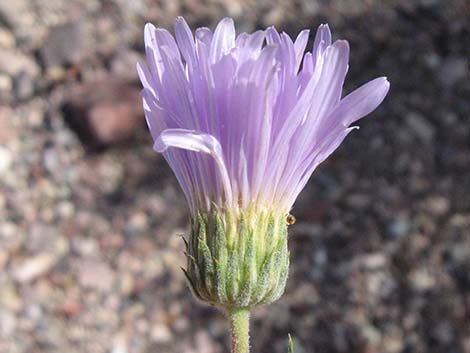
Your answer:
[39,22,85,69]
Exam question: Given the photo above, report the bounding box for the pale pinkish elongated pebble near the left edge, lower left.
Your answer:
[13,253,59,283]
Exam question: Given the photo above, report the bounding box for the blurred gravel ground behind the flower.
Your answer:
[0,0,470,353]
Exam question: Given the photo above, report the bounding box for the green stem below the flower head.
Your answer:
[227,308,250,353]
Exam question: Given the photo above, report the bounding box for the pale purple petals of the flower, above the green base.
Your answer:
[137,17,389,214]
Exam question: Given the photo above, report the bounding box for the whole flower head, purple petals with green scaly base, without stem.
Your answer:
[137,17,389,306]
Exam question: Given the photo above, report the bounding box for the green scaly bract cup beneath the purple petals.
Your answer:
[185,207,289,308]
